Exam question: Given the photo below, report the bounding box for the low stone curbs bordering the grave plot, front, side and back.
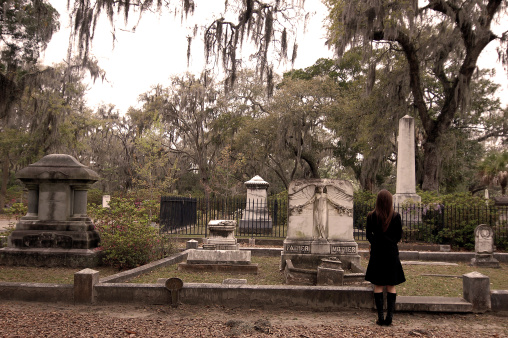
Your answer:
[0,248,508,312]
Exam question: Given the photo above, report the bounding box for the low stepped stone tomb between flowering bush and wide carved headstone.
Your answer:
[178,220,258,274]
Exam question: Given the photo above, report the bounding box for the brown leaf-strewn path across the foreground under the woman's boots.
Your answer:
[0,301,508,338]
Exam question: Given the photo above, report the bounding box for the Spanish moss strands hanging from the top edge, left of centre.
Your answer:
[68,0,310,93]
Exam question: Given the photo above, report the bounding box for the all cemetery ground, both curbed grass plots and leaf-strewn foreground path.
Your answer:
[0,257,508,337]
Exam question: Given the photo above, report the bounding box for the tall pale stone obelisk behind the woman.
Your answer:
[393,115,422,206]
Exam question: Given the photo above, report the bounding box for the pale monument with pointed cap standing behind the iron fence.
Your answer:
[240,175,273,234]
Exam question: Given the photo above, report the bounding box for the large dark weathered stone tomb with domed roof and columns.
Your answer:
[0,154,100,267]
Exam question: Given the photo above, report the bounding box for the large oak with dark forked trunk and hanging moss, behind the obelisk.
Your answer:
[326,0,508,190]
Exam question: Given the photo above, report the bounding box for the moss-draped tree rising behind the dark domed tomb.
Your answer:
[0,59,93,210]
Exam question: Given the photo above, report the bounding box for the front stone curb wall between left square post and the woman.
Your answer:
[95,283,374,309]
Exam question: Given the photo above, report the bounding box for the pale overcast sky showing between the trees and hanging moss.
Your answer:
[44,0,508,113]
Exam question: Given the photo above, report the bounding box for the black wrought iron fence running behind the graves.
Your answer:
[160,197,508,249]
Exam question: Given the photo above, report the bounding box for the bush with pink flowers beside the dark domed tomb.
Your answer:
[89,197,173,269]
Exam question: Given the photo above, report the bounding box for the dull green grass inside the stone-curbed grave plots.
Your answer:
[0,257,508,297]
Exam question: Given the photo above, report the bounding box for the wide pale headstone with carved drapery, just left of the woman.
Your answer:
[281,179,360,284]
